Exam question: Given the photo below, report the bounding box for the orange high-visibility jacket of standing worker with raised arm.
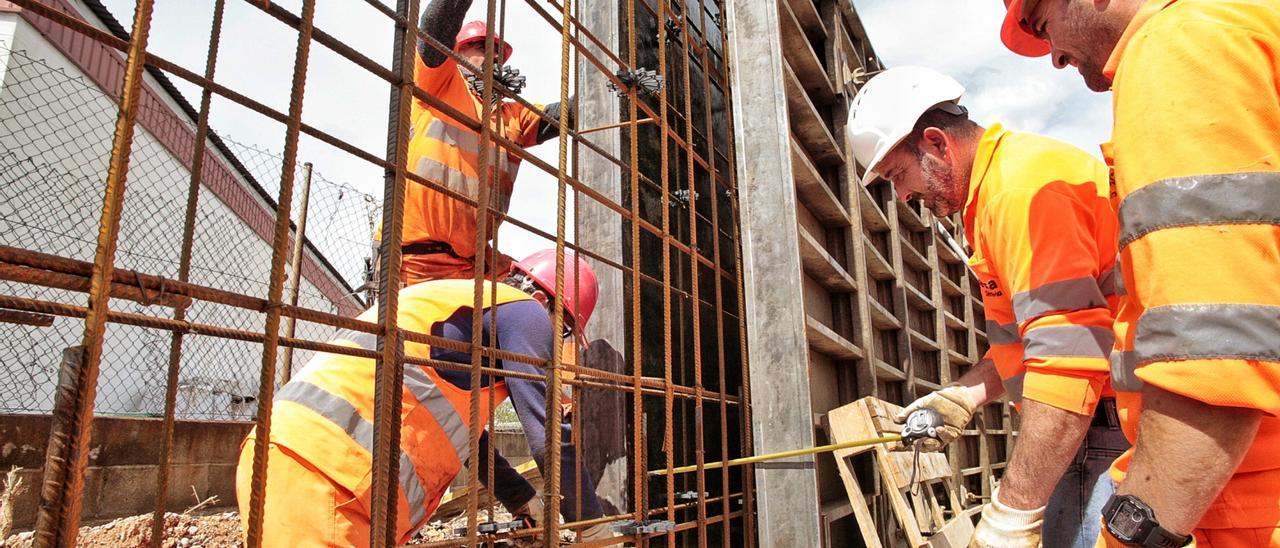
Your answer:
[402,55,541,257]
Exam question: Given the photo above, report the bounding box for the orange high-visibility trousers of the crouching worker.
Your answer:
[236,438,370,548]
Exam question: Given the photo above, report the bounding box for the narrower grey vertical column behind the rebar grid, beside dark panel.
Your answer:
[576,1,630,511]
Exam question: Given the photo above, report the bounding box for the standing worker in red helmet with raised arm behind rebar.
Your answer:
[375,0,572,286]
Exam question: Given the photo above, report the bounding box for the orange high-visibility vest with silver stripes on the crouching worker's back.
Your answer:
[246,279,531,544]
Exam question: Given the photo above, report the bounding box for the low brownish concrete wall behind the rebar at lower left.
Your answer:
[0,415,252,529]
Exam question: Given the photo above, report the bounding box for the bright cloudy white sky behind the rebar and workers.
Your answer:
[104,0,1111,259]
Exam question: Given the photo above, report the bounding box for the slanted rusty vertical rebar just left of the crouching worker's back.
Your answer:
[246,0,315,548]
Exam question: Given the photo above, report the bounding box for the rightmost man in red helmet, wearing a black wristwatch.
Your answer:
[1001,0,1280,547]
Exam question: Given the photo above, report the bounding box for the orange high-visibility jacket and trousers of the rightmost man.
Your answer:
[1105,0,1280,529]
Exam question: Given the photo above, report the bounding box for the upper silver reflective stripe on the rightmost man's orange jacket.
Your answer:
[1120,172,1280,250]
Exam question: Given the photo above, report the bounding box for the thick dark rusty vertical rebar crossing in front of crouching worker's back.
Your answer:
[369,0,417,547]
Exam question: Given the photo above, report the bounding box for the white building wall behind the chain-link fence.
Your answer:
[0,14,345,419]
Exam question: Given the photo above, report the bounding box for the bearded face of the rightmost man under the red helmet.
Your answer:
[1027,0,1133,92]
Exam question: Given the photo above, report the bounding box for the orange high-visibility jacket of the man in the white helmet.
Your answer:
[964,124,1119,415]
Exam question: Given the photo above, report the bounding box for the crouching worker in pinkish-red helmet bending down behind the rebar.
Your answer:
[236,250,612,547]
